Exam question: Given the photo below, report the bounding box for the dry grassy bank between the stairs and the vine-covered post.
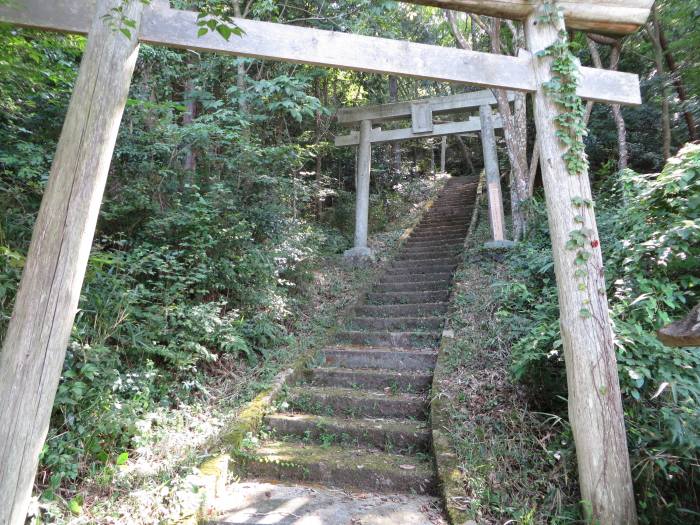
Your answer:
[437,216,579,524]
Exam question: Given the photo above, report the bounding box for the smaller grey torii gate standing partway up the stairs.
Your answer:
[335,90,514,257]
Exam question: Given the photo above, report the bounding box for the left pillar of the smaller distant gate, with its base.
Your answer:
[345,120,373,257]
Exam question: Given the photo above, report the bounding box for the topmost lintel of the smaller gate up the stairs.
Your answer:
[337,89,515,125]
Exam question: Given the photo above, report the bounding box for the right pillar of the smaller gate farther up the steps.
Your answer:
[479,106,506,241]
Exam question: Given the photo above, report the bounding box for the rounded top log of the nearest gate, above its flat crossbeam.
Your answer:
[404,0,653,35]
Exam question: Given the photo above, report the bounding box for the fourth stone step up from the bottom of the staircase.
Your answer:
[304,367,433,392]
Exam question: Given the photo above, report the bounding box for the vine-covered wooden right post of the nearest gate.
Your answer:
[525,8,637,525]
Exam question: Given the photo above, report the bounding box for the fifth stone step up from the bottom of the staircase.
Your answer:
[321,347,437,372]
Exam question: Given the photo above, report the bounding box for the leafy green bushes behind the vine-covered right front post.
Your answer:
[499,145,700,523]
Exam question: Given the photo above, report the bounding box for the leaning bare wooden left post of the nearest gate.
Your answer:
[0,0,142,525]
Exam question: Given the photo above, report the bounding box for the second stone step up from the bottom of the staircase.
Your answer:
[265,414,430,452]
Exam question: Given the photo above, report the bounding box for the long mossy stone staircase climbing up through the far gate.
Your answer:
[230,177,476,494]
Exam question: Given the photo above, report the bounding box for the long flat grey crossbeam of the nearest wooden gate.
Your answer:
[0,0,641,104]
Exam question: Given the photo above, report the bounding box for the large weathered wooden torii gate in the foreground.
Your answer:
[0,0,652,525]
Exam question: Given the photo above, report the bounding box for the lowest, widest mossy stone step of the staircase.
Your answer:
[233,441,436,494]
